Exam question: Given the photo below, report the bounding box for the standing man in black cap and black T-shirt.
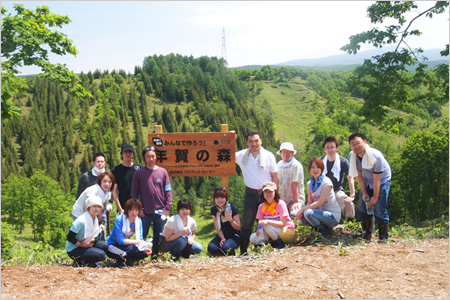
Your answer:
[111,144,143,214]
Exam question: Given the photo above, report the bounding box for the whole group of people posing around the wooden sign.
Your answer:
[66,131,391,267]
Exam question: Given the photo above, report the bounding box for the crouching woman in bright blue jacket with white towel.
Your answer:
[107,199,152,267]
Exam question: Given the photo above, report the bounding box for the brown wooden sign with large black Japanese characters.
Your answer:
[148,132,236,177]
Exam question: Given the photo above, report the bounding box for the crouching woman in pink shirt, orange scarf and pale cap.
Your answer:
[250,182,295,249]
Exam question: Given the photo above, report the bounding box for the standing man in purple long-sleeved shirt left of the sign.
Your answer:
[131,147,172,256]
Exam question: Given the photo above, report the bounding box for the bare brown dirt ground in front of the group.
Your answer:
[1,238,449,299]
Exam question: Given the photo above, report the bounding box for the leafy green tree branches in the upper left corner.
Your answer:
[1,4,91,121]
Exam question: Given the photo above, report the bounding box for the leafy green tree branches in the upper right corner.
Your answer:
[341,1,449,127]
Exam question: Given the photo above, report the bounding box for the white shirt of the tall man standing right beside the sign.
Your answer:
[235,148,278,190]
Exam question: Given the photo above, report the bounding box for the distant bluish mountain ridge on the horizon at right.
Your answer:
[273,46,445,67]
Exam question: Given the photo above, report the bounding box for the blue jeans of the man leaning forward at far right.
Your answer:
[358,181,391,224]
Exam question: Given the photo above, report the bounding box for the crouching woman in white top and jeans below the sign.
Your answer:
[162,199,203,260]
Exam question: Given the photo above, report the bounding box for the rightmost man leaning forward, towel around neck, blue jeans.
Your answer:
[348,133,392,243]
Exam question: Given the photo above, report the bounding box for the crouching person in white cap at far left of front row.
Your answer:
[66,195,112,268]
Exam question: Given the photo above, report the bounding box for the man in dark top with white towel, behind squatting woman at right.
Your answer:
[320,136,355,221]
